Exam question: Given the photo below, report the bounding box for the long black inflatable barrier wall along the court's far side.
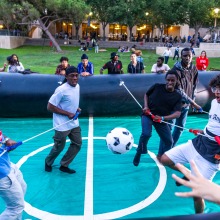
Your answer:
[0,72,220,117]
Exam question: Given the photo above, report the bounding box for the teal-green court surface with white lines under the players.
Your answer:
[0,114,220,220]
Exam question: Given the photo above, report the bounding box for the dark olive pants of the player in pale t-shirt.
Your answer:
[45,127,82,167]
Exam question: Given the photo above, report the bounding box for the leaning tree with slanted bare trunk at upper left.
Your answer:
[4,0,87,52]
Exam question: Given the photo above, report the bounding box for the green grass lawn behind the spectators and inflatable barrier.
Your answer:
[0,46,220,74]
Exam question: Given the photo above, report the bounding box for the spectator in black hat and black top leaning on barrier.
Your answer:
[100,52,124,74]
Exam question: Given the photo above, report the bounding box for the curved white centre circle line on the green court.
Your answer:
[17,138,167,220]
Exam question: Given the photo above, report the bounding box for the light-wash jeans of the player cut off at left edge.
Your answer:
[0,163,27,220]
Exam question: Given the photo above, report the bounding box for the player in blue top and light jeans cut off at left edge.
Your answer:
[0,131,27,220]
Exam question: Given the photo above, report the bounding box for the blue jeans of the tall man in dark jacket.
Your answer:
[172,107,189,147]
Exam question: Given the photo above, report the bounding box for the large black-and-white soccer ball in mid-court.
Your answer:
[106,128,134,154]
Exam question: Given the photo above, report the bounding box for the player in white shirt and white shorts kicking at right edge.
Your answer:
[160,75,220,213]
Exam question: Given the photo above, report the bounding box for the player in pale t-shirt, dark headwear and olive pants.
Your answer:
[45,66,82,174]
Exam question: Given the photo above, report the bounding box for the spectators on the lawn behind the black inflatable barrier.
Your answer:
[0,45,209,76]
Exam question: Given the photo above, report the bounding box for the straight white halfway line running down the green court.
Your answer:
[84,117,94,219]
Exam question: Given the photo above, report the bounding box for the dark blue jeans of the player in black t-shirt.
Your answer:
[137,115,173,156]
